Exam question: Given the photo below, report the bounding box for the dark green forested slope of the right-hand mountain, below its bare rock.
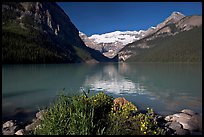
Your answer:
[123,24,202,62]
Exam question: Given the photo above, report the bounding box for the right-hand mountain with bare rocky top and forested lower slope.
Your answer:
[118,12,202,62]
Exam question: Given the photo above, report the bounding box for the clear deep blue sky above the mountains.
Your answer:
[57,2,202,36]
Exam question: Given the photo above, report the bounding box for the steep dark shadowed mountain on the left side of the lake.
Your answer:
[2,2,113,63]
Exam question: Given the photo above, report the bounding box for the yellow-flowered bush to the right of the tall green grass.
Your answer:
[106,103,165,135]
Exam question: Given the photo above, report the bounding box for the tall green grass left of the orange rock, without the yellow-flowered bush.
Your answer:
[34,93,113,135]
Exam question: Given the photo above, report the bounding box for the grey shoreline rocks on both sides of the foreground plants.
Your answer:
[2,99,202,135]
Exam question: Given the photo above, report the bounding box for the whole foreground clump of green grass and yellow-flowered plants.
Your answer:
[33,92,165,135]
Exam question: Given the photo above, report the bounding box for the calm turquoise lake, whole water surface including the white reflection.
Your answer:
[2,63,202,121]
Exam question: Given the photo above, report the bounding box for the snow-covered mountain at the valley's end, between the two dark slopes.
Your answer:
[80,30,145,58]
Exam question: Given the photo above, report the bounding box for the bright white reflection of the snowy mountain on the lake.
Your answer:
[84,64,145,94]
